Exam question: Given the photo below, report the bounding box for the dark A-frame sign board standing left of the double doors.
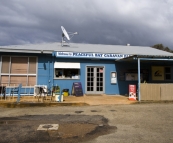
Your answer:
[72,82,83,96]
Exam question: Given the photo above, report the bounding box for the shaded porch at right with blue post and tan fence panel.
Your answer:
[117,56,173,101]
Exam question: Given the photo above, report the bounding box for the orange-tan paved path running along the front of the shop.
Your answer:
[0,94,138,106]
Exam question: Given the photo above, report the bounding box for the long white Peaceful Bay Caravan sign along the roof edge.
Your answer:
[55,52,130,59]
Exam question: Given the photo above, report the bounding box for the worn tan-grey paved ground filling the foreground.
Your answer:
[0,103,173,143]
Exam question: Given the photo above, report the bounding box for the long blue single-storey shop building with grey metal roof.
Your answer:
[0,43,173,100]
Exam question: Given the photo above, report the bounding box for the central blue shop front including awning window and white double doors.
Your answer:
[53,59,119,94]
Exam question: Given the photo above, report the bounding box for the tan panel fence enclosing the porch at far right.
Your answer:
[140,83,173,101]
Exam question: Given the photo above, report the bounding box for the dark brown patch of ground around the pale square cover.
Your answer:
[0,114,116,143]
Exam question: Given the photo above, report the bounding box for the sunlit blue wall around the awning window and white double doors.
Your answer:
[53,58,119,94]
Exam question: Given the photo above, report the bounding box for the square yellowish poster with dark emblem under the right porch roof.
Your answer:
[152,66,164,80]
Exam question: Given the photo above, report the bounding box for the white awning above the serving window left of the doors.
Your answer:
[54,62,80,69]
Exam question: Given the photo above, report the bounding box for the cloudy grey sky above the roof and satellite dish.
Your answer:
[0,0,173,50]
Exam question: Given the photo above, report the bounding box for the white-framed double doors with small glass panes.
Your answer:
[86,66,105,94]
